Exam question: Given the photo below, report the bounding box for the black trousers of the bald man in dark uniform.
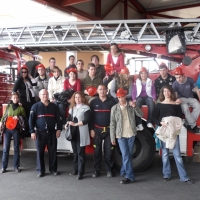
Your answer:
[36,131,57,173]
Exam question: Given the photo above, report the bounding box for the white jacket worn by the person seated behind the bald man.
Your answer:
[48,76,65,99]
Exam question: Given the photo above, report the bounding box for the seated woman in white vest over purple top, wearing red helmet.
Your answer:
[132,67,156,131]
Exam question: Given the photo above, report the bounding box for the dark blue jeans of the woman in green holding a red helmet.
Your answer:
[2,129,20,169]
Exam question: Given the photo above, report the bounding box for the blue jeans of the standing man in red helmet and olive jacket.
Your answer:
[117,136,135,181]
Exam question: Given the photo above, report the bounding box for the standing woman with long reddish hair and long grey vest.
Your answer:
[65,92,91,180]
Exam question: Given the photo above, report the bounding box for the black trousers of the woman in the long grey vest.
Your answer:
[71,130,85,175]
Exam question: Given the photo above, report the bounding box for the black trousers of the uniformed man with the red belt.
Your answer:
[93,128,114,171]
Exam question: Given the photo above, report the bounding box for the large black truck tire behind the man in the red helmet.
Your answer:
[114,127,156,172]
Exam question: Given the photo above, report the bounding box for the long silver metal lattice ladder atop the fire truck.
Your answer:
[0,19,200,51]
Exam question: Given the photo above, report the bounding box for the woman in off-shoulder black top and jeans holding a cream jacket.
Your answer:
[154,86,193,184]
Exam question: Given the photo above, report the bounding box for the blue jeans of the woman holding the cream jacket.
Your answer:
[161,136,189,181]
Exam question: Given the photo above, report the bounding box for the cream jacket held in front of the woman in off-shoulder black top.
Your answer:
[156,116,183,149]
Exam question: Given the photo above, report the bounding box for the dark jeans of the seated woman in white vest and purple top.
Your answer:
[136,97,154,125]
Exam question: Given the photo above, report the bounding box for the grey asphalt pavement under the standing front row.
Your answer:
[0,145,200,200]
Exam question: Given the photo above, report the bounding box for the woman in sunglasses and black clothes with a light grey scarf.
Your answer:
[13,65,37,118]
